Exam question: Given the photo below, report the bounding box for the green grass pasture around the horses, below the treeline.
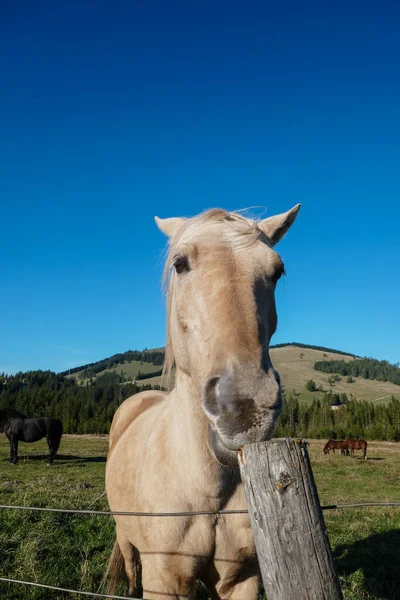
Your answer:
[0,436,400,600]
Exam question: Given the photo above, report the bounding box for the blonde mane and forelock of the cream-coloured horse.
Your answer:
[162,208,272,389]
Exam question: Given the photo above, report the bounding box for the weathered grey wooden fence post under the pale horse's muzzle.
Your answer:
[239,439,343,600]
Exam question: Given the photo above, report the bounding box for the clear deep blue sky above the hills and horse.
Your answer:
[0,0,400,372]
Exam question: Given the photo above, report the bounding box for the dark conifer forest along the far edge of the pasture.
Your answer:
[0,371,400,441]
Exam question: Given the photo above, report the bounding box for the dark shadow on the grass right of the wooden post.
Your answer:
[334,529,400,600]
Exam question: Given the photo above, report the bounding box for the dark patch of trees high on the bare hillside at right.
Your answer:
[314,358,400,385]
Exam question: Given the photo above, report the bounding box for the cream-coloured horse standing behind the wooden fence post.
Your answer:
[106,205,300,600]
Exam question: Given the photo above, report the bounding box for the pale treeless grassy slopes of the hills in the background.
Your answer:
[71,344,400,404]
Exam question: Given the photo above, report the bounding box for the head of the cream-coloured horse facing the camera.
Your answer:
[156,205,300,451]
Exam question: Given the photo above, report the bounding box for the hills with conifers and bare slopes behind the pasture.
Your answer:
[0,344,400,440]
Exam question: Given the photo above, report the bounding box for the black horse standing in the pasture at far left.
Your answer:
[0,408,62,465]
